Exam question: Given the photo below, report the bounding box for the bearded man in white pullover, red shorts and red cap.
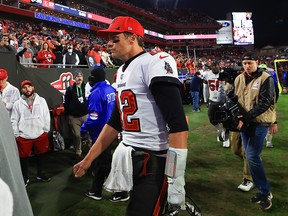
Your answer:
[11,80,51,186]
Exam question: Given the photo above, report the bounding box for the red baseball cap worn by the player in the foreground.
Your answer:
[97,16,144,38]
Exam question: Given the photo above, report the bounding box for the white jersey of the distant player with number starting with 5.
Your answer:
[202,70,225,102]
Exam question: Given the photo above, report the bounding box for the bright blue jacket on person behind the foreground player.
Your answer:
[80,81,115,142]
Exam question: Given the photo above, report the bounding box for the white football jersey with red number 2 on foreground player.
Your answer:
[116,52,179,151]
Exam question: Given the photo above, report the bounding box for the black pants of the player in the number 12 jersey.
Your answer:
[126,151,167,216]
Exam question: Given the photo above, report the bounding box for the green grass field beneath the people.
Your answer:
[27,95,288,216]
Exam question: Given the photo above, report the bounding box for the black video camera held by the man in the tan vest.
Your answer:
[214,89,241,131]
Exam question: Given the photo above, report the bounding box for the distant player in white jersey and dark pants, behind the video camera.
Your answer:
[203,62,230,148]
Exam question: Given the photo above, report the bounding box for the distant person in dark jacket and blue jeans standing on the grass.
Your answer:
[190,71,203,112]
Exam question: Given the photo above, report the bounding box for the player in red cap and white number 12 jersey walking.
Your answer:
[73,16,188,216]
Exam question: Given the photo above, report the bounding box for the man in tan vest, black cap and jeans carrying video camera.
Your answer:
[234,52,277,210]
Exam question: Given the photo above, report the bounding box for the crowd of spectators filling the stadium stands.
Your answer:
[0,11,287,73]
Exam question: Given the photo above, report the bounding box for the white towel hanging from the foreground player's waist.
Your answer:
[104,142,133,193]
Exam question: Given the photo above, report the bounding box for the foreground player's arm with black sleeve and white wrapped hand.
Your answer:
[151,82,188,206]
